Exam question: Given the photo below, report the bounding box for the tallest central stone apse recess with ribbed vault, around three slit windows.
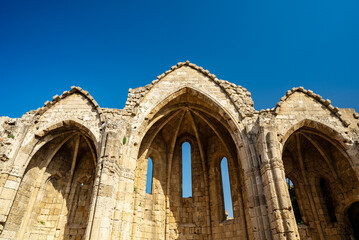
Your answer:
[133,88,248,239]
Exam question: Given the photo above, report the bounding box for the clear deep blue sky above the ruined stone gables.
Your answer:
[0,0,359,117]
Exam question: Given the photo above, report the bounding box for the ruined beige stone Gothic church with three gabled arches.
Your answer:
[0,61,359,240]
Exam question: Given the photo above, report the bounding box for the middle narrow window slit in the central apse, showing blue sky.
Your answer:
[182,142,192,197]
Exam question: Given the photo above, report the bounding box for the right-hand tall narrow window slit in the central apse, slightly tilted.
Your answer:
[221,157,233,220]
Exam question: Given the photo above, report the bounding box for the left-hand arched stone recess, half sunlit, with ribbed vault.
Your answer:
[4,125,97,239]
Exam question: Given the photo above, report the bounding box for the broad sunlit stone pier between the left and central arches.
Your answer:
[85,129,135,240]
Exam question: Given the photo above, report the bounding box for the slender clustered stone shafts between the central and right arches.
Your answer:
[258,126,300,239]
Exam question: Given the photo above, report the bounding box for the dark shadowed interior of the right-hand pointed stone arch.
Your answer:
[282,126,359,239]
